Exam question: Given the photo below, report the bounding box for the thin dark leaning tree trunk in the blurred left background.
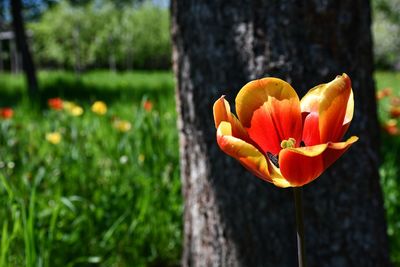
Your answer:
[10,0,39,97]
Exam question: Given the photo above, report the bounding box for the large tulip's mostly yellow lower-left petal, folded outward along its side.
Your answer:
[217,121,272,182]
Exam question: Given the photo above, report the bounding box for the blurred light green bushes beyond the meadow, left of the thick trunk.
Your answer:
[29,1,171,71]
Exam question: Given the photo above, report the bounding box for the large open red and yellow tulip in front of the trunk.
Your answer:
[213,74,358,187]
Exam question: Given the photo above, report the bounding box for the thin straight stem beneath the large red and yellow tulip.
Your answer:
[293,187,307,267]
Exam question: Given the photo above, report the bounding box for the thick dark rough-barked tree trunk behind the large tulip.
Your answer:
[172,0,389,267]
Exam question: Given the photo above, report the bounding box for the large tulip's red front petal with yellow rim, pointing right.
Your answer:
[279,136,358,186]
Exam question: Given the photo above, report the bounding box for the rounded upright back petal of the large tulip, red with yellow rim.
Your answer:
[236,78,302,155]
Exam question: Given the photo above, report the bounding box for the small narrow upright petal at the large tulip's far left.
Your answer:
[213,96,250,142]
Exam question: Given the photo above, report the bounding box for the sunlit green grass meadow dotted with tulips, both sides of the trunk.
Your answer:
[0,71,400,267]
